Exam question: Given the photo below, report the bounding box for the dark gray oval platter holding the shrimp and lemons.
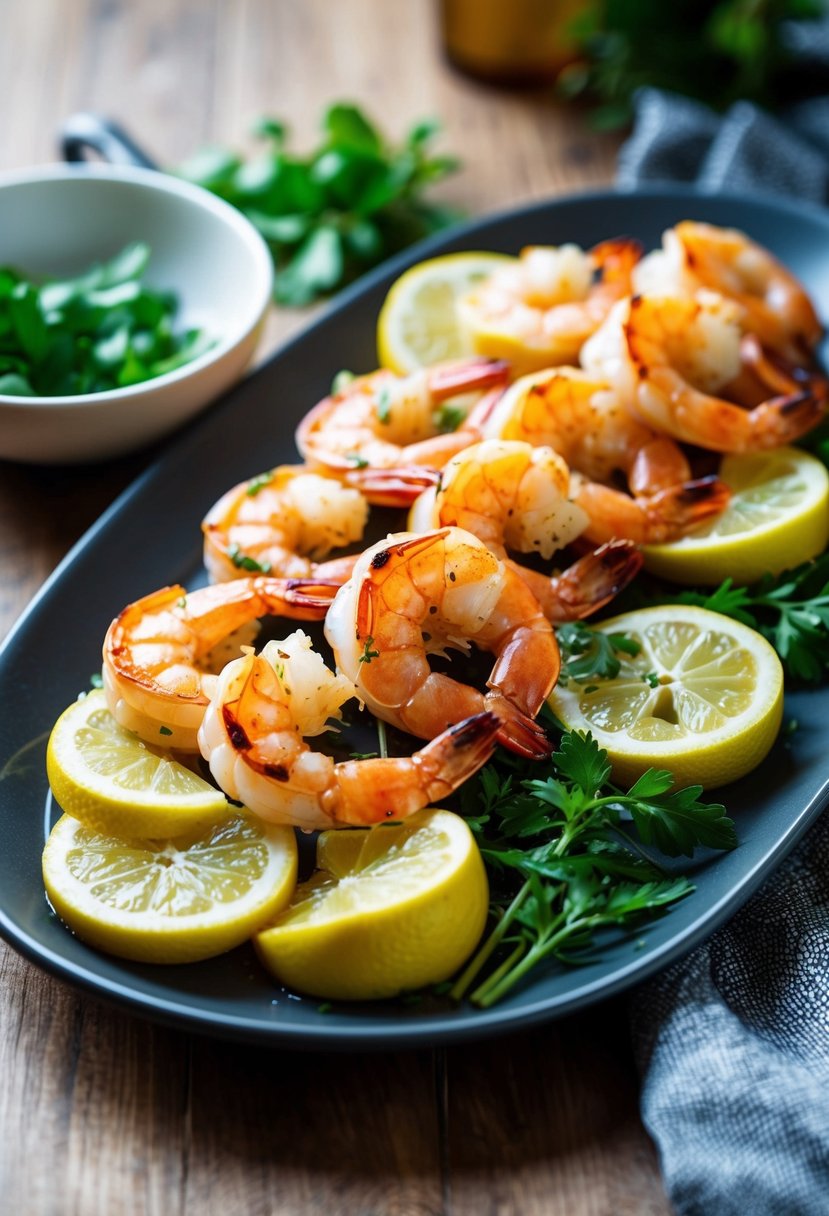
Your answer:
[0,186,829,1049]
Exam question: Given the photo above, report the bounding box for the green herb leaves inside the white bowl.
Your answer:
[0,242,214,396]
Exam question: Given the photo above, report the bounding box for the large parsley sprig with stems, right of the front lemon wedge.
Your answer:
[451,732,737,1007]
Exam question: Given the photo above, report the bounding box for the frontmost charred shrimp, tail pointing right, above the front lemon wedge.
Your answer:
[198,632,498,831]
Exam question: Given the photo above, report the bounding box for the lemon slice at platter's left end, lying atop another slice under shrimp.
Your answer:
[46,689,229,837]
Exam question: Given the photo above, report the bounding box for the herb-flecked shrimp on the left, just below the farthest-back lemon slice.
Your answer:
[297,359,508,488]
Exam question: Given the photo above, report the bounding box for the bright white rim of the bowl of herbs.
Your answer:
[0,162,273,410]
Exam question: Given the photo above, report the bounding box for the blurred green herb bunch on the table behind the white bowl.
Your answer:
[177,102,459,305]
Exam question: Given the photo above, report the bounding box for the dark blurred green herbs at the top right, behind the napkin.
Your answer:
[559,0,825,129]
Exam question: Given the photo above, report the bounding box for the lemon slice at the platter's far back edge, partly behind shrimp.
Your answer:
[377,253,513,376]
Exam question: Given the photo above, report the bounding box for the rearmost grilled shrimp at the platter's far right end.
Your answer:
[633,220,823,364]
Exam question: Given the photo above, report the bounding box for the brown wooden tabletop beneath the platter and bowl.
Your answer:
[0,0,670,1216]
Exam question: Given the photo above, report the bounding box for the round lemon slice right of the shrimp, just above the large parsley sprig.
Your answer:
[549,604,783,789]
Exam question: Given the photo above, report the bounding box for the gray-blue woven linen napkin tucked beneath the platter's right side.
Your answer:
[617,22,829,1216]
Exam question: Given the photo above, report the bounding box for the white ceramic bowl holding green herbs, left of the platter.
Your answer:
[0,164,273,465]
